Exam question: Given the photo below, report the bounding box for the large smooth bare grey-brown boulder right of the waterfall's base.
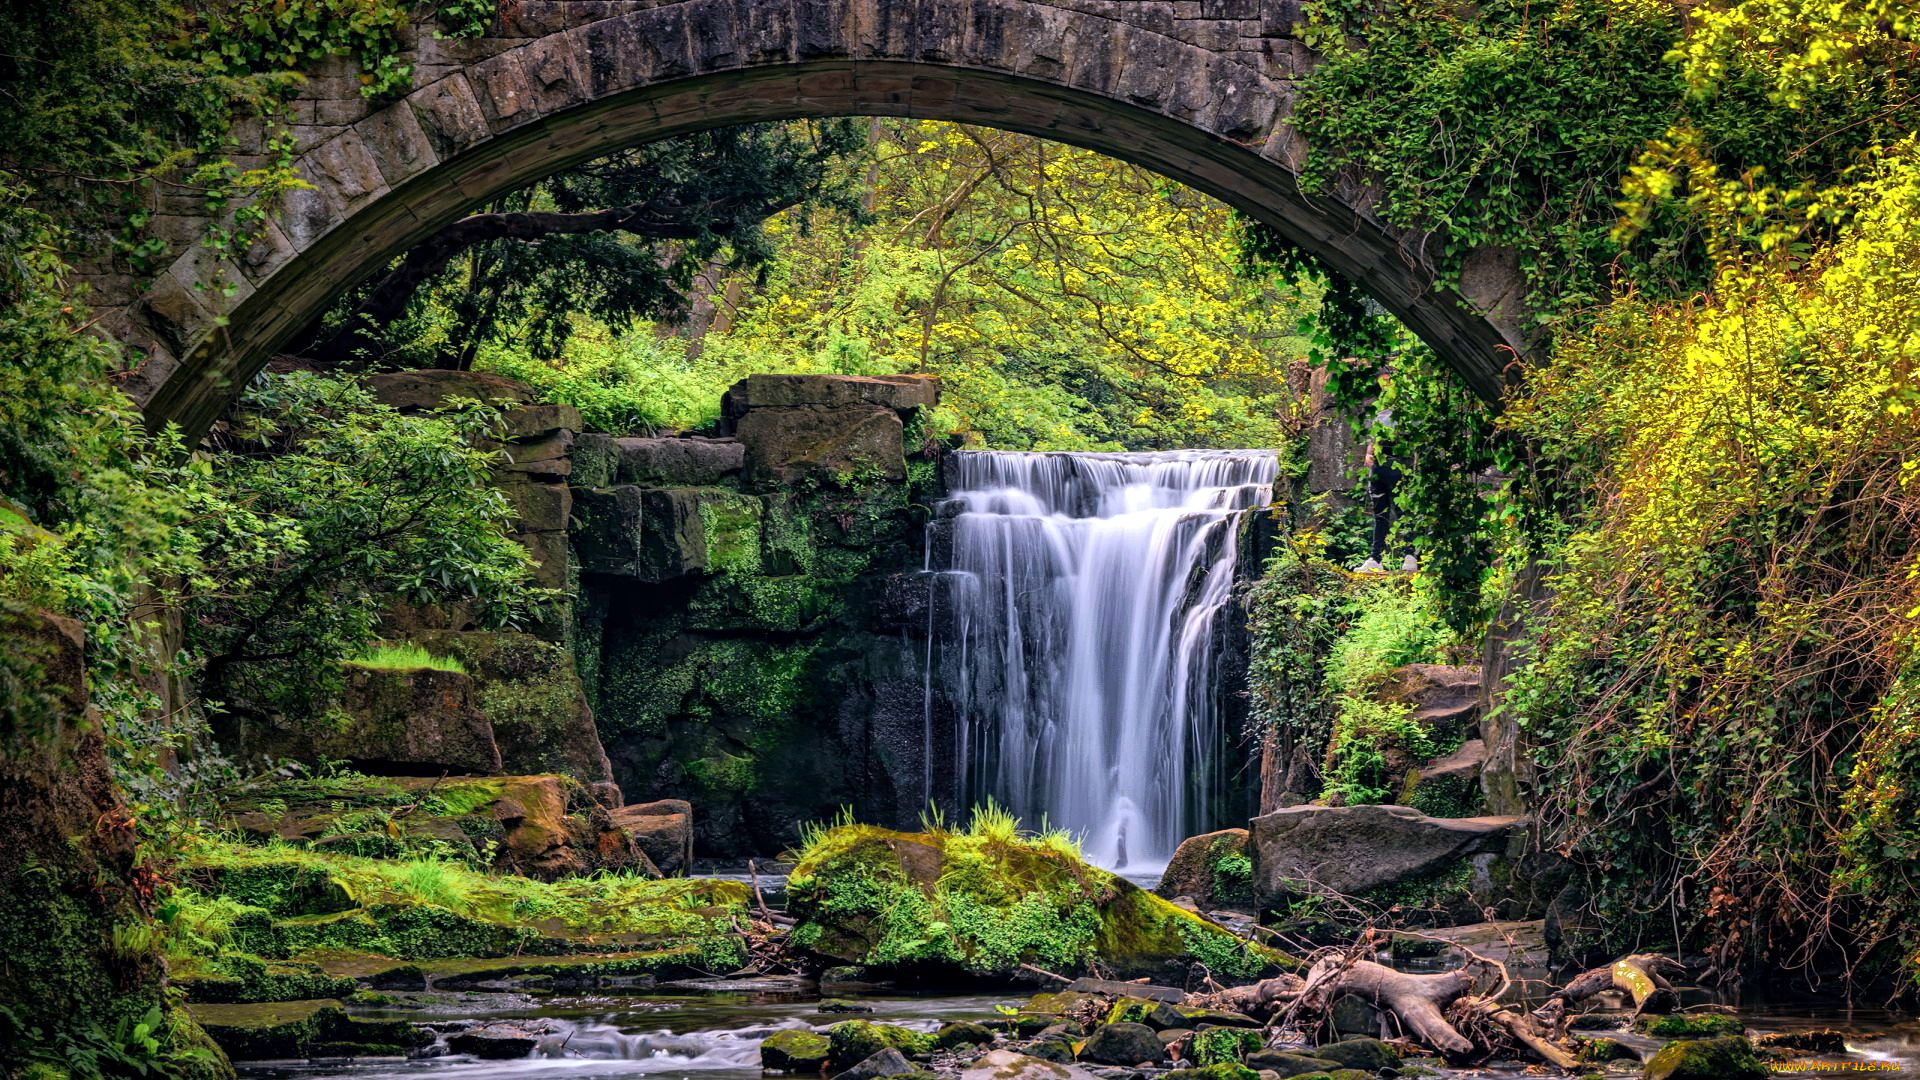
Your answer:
[1250,805,1523,907]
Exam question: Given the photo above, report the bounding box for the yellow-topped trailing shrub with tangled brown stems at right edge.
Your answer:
[1503,146,1920,976]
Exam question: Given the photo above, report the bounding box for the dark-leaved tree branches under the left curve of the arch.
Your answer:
[301,119,864,369]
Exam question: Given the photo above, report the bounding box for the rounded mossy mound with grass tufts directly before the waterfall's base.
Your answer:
[787,815,1294,980]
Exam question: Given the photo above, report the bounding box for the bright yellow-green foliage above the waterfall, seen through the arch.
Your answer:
[472,119,1319,450]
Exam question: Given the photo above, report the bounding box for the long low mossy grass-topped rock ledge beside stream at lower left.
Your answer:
[157,840,747,1001]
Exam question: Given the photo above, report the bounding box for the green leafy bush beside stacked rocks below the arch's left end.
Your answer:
[184,373,541,711]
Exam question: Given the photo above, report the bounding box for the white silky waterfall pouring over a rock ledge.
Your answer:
[927,450,1277,869]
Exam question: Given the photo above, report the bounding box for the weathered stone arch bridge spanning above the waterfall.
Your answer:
[116,0,1528,434]
